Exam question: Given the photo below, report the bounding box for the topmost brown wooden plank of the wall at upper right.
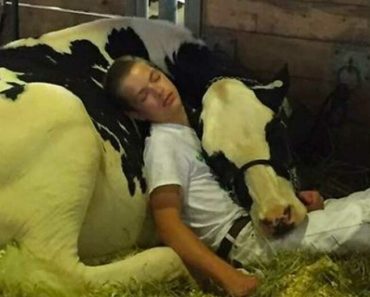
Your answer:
[205,0,370,45]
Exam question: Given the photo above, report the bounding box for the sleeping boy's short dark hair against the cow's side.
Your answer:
[103,56,153,111]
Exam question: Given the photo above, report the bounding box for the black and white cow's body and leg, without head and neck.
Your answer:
[0,18,202,283]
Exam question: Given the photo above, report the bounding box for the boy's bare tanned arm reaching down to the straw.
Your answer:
[150,185,257,296]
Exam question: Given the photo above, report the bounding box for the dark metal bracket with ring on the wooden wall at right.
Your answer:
[333,45,370,90]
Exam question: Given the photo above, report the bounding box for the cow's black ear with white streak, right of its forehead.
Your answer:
[252,64,290,113]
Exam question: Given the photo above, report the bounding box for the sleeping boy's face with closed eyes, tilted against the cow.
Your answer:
[122,62,183,123]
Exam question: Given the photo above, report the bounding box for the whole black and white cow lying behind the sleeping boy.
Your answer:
[0,18,305,284]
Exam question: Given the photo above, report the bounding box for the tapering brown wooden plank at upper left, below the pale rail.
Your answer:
[19,7,97,38]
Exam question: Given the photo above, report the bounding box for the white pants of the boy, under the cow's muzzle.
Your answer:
[229,189,370,265]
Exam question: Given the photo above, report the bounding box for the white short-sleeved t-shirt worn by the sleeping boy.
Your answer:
[144,124,246,250]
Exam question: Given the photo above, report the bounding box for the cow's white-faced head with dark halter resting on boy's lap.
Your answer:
[200,69,306,235]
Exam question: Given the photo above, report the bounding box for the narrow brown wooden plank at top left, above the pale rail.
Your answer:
[19,0,126,15]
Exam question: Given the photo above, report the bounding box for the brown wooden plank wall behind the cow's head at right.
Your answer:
[202,0,370,167]
